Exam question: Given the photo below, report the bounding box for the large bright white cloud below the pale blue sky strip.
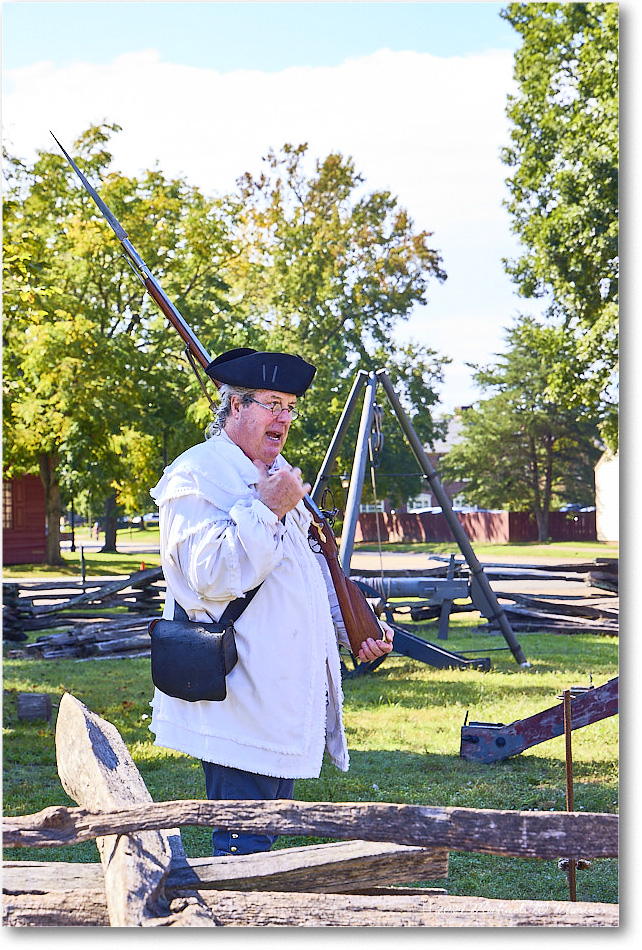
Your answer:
[3,50,515,405]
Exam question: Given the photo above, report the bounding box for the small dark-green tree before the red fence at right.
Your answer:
[442,317,600,541]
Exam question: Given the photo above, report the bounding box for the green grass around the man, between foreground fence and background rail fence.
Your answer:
[4,619,618,903]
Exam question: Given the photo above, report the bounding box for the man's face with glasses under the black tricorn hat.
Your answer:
[225,389,296,465]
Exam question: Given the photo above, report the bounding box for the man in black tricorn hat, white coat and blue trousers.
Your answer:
[150,348,393,855]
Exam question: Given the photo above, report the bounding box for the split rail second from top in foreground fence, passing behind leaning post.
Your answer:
[2,841,448,896]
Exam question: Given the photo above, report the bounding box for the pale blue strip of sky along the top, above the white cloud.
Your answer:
[3,2,517,72]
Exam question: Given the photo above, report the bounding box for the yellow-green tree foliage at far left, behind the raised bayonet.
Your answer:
[3,126,238,563]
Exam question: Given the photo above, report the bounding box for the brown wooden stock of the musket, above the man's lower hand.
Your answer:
[304,510,384,659]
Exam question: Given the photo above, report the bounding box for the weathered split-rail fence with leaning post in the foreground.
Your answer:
[3,694,618,927]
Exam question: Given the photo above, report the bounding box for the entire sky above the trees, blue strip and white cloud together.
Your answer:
[2,2,639,420]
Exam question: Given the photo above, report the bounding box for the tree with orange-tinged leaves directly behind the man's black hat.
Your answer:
[230,145,446,488]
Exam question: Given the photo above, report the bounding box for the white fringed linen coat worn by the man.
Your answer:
[150,432,349,778]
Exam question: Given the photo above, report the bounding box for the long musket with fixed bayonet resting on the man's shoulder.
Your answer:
[51,132,385,659]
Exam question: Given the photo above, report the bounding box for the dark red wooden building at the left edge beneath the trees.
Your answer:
[2,475,47,564]
